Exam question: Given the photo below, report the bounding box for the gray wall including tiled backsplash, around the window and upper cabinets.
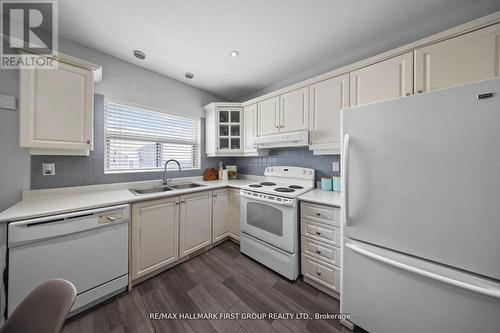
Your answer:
[0,40,339,195]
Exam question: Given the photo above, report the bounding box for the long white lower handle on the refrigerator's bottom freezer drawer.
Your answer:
[345,243,500,299]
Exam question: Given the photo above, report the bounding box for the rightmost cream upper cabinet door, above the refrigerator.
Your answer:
[415,24,500,92]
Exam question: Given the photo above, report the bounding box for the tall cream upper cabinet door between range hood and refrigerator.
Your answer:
[309,74,349,150]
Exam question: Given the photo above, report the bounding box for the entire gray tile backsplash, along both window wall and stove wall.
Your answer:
[31,94,340,189]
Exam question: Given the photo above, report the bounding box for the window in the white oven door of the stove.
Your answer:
[247,202,283,237]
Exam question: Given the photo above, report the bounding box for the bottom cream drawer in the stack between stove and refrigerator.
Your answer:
[302,254,340,293]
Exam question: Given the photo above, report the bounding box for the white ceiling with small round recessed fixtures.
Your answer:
[59,0,500,100]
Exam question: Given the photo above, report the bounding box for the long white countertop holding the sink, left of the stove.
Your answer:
[0,176,261,223]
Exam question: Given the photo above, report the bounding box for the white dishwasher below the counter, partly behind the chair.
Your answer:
[7,205,129,316]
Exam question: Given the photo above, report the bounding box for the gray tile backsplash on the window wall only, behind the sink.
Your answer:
[31,94,232,189]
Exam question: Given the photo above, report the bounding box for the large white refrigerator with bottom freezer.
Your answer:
[340,79,500,333]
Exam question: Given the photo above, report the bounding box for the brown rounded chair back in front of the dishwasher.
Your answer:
[0,279,76,333]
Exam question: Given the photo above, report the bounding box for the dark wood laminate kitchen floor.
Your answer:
[64,241,364,333]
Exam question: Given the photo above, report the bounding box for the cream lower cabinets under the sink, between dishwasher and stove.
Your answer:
[130,188,240,282]
